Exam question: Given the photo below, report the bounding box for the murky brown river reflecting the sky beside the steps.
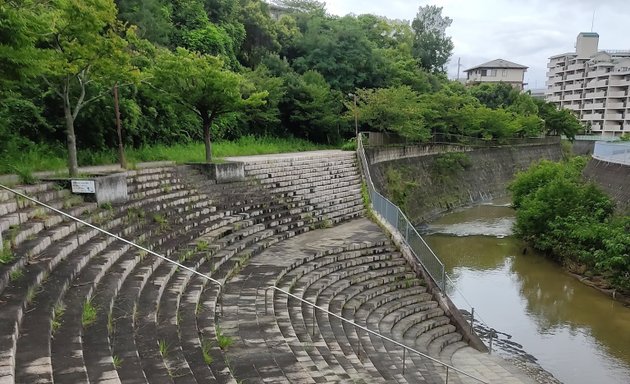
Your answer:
[423,204,630,384]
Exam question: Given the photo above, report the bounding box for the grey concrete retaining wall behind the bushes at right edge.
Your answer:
[583,159,630,213]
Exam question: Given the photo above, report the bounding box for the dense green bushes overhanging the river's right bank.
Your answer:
[509,157,630,294]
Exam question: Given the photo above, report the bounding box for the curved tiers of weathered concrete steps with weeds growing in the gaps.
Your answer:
[0,153,474,384]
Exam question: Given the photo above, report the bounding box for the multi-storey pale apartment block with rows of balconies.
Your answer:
[546,32,630,137]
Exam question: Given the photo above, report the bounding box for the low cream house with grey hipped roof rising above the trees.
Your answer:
[464,59,527,90]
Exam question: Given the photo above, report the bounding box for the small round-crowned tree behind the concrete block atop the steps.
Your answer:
[153,48,267,162]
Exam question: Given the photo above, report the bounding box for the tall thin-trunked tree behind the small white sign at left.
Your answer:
[38,0,135,176]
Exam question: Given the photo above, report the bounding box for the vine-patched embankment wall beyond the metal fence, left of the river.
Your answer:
[366,143,562,224]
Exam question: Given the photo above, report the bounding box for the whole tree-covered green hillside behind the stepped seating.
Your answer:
[0,0,580,174]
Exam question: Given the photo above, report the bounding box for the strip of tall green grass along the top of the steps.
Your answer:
[0,136,331,174]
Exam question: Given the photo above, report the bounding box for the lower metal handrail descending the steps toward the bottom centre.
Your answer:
[265,285,489,384]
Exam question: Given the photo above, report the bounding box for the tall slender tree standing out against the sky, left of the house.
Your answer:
[411,5,454,73]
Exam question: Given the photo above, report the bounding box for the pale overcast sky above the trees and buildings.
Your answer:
[326,0,630,88]
